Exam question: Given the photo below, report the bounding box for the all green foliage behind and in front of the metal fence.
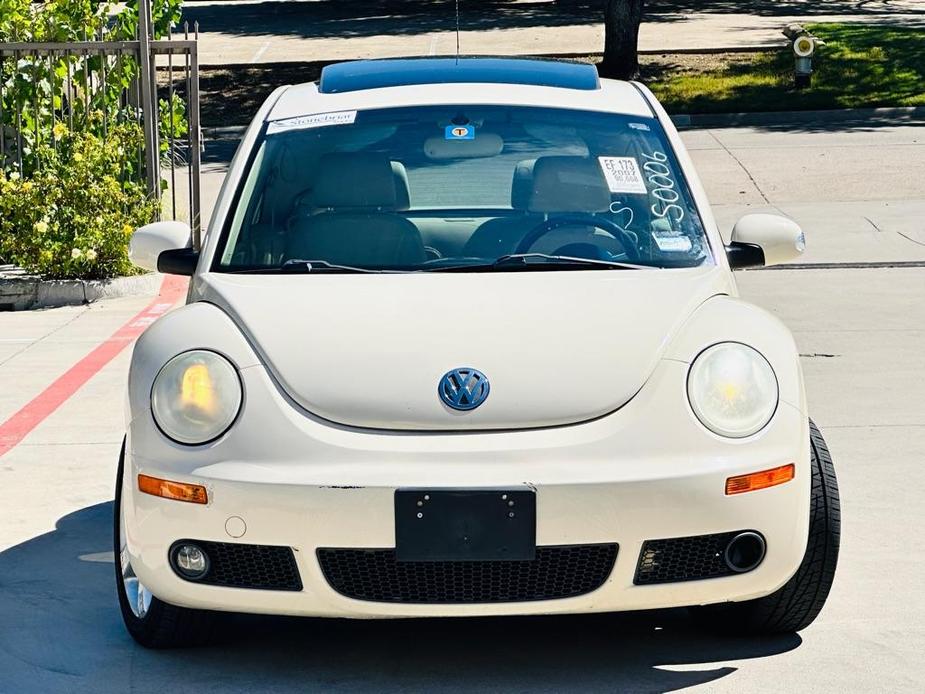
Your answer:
[0,0,187,279]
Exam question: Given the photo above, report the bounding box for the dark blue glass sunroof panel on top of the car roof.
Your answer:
[318,58,601,94]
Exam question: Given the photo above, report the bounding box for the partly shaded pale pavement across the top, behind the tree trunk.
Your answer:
[183,0,925,65]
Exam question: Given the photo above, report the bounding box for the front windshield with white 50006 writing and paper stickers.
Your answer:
[214,105,711,272]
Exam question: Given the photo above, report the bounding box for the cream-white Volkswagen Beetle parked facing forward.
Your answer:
[114,59,839,647]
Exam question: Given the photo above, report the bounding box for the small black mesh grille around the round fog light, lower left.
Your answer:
[171,540,302,591]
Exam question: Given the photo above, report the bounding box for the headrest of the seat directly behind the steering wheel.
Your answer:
[528,157,610,212]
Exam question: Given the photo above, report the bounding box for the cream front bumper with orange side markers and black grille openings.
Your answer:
[123,360,810,617]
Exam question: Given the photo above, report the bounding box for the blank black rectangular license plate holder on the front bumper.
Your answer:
[395,489,536,561]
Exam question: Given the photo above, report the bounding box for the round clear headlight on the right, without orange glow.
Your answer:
[687,342,778,439]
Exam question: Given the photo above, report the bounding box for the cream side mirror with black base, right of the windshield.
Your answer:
[726,214,806,270]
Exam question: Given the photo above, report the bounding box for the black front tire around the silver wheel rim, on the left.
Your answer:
[112,441,222,649]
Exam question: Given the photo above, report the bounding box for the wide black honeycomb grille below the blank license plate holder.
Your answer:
[317,544,618,604]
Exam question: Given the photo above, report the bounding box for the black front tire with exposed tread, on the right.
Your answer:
[693,422,841,634]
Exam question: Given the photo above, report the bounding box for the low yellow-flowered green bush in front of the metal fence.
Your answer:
[0,124,158,279]
